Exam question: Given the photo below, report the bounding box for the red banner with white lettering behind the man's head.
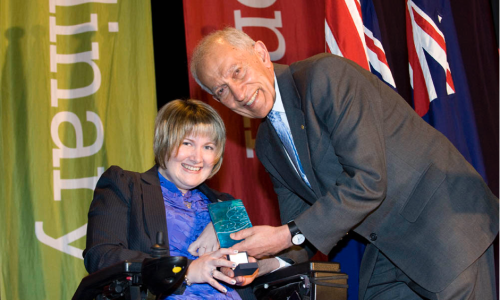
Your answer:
[184,0,325,225]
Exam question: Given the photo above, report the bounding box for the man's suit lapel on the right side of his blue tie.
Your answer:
[274,64,320,196]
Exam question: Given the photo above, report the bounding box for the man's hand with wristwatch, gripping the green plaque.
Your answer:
[230,225,292,258]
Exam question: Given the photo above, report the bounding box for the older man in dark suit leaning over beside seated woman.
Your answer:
[191,28,500,299]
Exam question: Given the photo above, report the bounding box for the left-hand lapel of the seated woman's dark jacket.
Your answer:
[141,166,168,248]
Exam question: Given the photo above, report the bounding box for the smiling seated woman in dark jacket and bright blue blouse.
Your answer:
[83,100,258,299]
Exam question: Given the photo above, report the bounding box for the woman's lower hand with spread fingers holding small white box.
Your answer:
[186,248,238,293]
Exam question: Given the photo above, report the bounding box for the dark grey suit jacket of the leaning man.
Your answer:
[256,54,500,292]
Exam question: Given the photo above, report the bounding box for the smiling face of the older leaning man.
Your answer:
[198,41,276,118]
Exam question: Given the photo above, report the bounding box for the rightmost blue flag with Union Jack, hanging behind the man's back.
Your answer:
[406,0,486,179]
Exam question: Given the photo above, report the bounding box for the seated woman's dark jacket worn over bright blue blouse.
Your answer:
[83,166,255,299]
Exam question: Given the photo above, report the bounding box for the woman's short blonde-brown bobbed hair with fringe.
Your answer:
[154,99,226,178]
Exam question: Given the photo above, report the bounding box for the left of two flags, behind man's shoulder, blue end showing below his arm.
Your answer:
[325,0,396,300]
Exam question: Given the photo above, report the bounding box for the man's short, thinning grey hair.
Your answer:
[190,27,255,95]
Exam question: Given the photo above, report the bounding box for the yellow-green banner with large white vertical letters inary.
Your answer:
[0,0,156,300]
